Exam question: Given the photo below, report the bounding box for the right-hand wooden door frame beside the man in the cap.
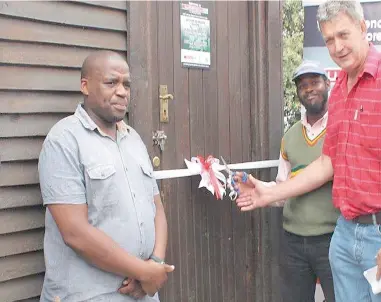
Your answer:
[249,1,283,302]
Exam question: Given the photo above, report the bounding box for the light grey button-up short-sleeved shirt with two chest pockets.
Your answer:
[38,105,159,302]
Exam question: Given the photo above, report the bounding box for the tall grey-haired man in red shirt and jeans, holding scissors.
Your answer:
[236,1,381,302]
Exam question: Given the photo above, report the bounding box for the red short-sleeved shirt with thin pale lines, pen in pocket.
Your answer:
[323,45,381,219]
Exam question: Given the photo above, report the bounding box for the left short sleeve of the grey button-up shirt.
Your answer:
[38,136,86,205]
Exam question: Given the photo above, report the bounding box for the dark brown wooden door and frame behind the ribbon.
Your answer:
[129,1,282,302]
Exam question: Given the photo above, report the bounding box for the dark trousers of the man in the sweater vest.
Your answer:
[280,231,335,302]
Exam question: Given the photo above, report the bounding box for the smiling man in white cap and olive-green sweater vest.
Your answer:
[238,61,339,302]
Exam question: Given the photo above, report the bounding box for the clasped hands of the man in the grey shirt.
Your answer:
[140,260,175,297]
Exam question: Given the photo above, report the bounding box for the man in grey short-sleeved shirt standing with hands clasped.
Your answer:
[39,51,174,302]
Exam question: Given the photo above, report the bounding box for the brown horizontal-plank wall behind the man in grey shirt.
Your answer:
[0,1,127,302]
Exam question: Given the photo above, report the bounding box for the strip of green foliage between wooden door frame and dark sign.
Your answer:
[283,0,304,130]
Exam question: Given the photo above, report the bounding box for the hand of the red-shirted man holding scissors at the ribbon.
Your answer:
[235,173,270,212]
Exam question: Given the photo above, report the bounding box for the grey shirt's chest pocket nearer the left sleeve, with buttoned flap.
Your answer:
[86,164,118,209]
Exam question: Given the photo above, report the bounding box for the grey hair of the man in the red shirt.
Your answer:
[316,0,364,30]
